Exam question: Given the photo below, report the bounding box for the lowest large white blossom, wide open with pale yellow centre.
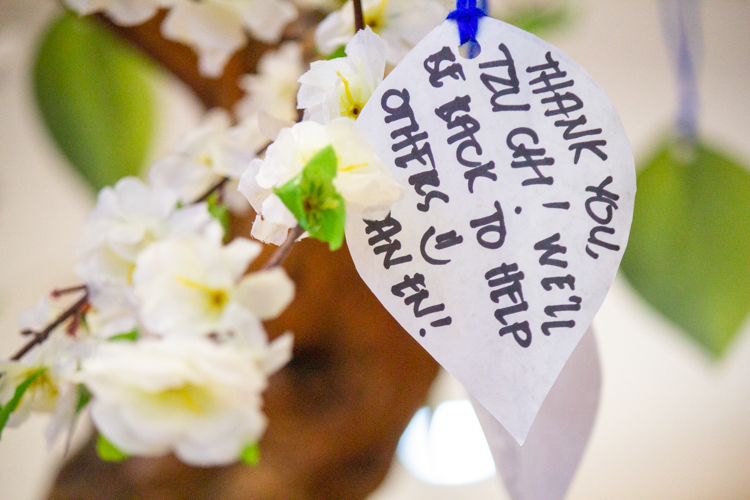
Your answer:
[81,334,291,466]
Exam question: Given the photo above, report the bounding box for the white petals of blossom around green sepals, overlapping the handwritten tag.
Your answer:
[240,117,404,244]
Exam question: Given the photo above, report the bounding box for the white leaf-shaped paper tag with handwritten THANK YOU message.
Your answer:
[346,18,635,444]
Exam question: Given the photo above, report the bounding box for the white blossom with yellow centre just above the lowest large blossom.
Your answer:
[133,237,294,338]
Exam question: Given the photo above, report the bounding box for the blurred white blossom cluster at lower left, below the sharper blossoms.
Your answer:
[0,111,294,465]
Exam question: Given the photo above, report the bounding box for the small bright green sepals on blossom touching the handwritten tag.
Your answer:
[274,146,346,250]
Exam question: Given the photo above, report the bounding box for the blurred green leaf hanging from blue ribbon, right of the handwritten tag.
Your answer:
[621,137,750,357]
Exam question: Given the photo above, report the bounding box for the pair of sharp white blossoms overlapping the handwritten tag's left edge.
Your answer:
[244,27,404,245]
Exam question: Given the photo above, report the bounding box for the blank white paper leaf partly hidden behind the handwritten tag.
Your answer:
[470,329,601,500]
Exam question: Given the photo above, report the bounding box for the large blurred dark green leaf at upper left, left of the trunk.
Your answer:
[34,13,155,190]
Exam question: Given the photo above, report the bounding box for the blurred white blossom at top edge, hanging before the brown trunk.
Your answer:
[161,0,297,78]
